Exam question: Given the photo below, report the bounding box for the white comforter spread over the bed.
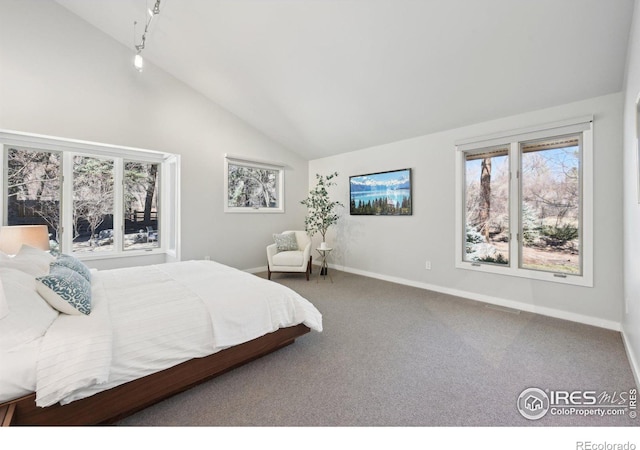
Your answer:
[36,261,322,406]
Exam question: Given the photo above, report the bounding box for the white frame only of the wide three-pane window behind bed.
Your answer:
[0,130,180,260]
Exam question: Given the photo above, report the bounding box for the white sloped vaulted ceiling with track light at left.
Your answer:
[58,0,633,159]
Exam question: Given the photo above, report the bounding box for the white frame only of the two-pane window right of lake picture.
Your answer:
[455,116,593,287]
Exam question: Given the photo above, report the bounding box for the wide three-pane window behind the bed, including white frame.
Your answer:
[0,131,180,259]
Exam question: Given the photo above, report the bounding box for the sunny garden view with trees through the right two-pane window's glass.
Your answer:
[463,135,582,274]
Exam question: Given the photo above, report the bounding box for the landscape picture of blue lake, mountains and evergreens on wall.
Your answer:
[349,169,412,216]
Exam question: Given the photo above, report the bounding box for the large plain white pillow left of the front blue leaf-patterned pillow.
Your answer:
[0,268,58,351]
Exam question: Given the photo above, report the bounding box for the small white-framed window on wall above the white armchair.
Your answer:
[224,155,284,213]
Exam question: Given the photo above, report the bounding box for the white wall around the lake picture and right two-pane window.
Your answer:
[309,94,622,329]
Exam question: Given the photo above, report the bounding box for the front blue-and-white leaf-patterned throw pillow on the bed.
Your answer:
[36,266,91,315]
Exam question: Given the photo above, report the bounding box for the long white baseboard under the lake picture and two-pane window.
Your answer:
[329,264,622,331]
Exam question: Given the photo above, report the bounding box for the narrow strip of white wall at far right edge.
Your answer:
[623,0,640,384]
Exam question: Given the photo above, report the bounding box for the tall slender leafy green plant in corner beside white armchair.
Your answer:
[300,172,343,272]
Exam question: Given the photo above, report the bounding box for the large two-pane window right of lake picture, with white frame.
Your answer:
[456,118,593,286]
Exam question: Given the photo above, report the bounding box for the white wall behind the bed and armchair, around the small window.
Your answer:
[0,0,308,269]
